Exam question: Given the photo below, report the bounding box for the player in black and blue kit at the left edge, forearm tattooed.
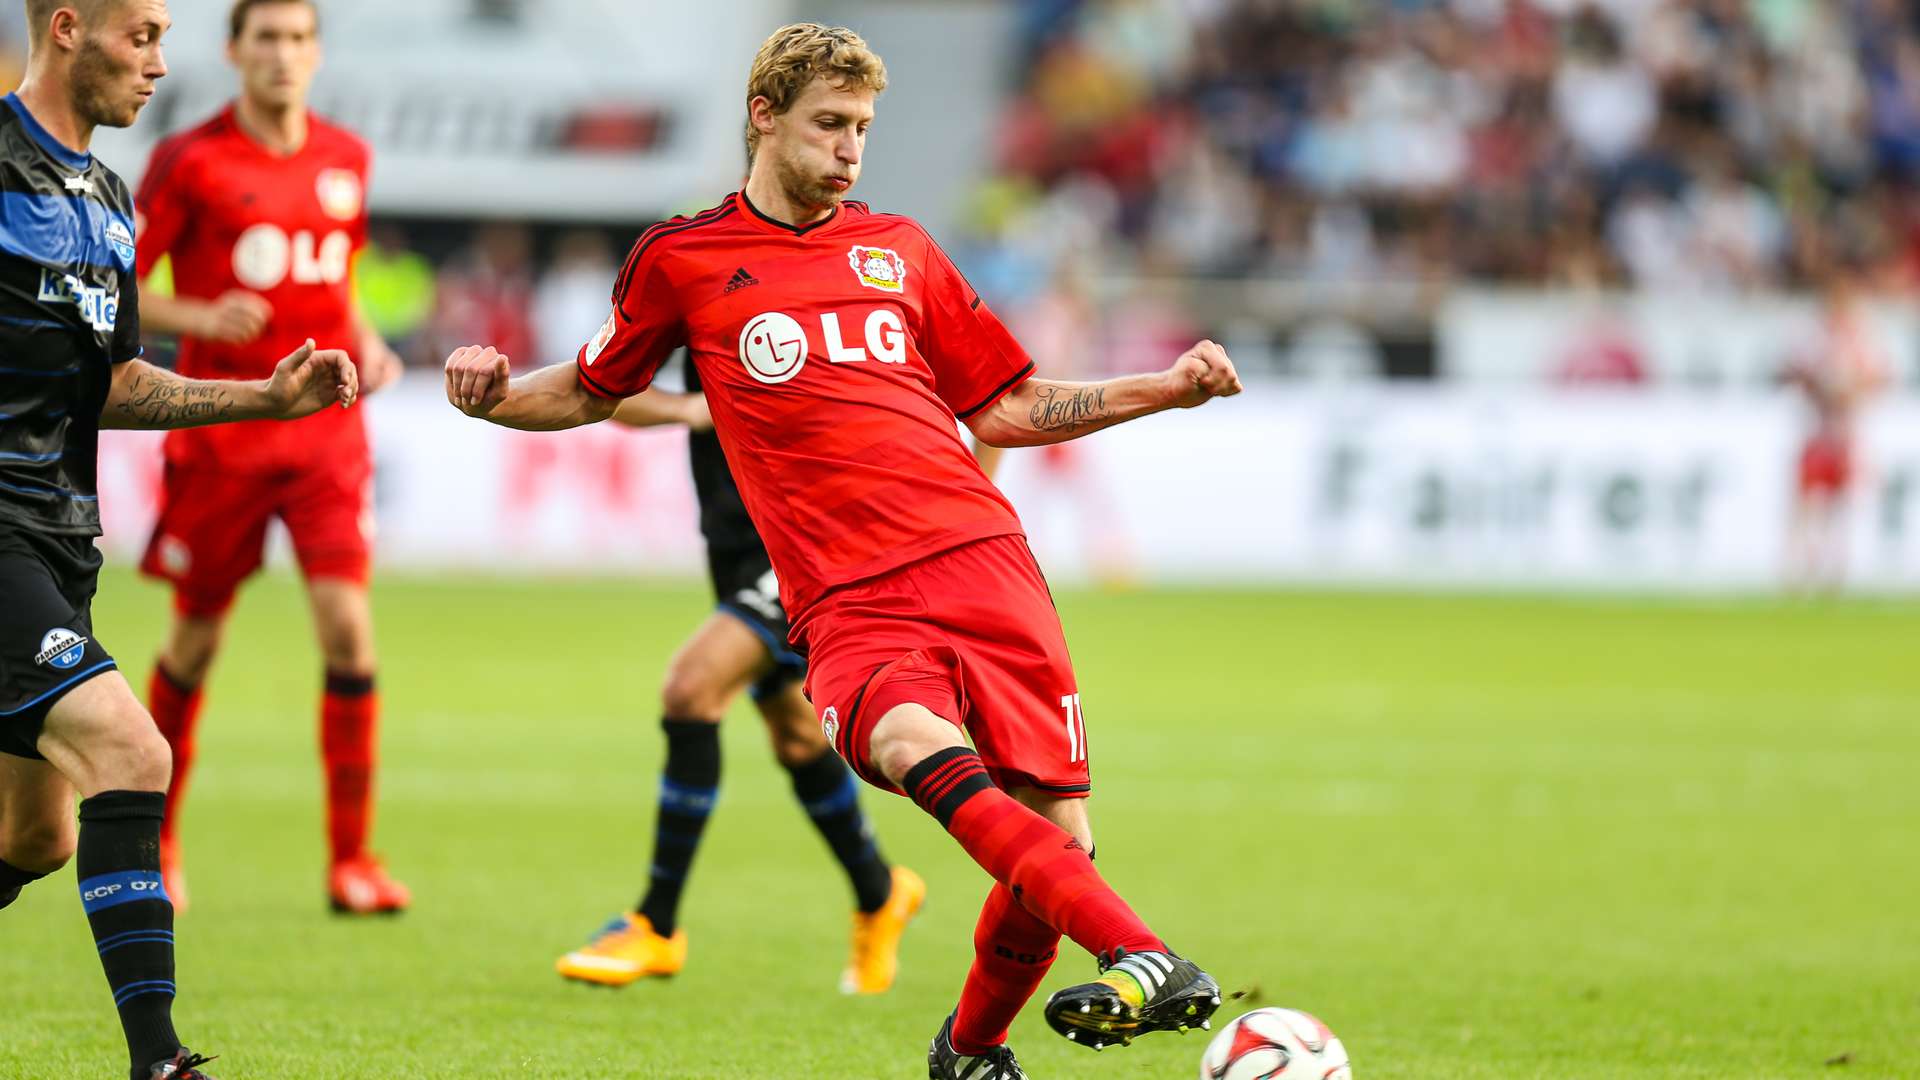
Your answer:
[0,0,359,1080]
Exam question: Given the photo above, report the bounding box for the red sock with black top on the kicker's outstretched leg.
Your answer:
[906,746,1167,955]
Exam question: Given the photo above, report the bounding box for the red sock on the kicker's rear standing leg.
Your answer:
[952,882,1060,1057]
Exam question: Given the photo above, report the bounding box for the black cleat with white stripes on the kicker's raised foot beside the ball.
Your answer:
[1046,949,1219,1049]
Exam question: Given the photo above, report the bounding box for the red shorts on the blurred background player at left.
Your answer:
[140,463,372,619]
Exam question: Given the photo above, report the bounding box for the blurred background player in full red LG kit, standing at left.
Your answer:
[136,0,409,915]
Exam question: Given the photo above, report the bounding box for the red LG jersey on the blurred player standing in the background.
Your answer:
[134,106,369,471]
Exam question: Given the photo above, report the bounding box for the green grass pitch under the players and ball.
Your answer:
[0,571,1920,1080]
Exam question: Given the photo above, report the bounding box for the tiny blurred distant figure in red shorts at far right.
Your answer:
[1786,265,1891,590]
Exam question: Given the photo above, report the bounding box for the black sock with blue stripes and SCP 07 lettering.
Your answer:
[77,792,180,1080]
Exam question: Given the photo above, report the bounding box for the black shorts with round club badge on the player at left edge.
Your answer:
[0,521,113,759]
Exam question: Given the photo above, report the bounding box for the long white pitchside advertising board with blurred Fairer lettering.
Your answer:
[102,377,1920,590]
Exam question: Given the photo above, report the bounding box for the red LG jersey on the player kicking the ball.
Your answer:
[578,192,1033,622]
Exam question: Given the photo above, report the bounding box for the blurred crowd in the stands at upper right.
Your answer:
[975,0,1920,290]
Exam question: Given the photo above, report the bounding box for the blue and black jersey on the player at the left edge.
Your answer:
[0,94,140,536]
